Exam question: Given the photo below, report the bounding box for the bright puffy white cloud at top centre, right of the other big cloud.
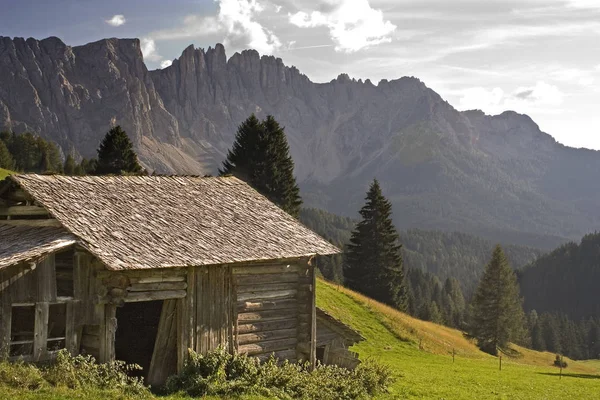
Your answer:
[288,0,396,53]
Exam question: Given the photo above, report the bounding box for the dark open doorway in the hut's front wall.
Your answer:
[115,300,163,377]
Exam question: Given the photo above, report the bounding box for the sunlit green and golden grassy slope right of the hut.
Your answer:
[317,282,600,400]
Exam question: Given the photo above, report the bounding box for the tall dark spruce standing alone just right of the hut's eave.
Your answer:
[344,179,407,311]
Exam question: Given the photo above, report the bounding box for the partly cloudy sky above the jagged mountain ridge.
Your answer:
[0,0,600,149]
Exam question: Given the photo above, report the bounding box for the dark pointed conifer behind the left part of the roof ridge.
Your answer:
[95,126,144,175]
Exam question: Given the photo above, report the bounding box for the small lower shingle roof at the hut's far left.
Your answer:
[0,225,76,269]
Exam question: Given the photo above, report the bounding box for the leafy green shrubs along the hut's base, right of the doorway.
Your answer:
[165,348,393,400]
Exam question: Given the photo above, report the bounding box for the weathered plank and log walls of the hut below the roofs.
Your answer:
[0,249,316,384]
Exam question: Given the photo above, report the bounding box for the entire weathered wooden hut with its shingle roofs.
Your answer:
[0,175,339,384]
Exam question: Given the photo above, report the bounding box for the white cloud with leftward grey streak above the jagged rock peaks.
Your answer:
[150,0,281,54]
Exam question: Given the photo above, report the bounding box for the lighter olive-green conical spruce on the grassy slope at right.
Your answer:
[470,245,524,355]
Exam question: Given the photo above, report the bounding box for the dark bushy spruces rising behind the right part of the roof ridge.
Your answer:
[219,114,302,218]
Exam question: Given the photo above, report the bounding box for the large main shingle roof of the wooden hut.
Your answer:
[11,175,339,270]
